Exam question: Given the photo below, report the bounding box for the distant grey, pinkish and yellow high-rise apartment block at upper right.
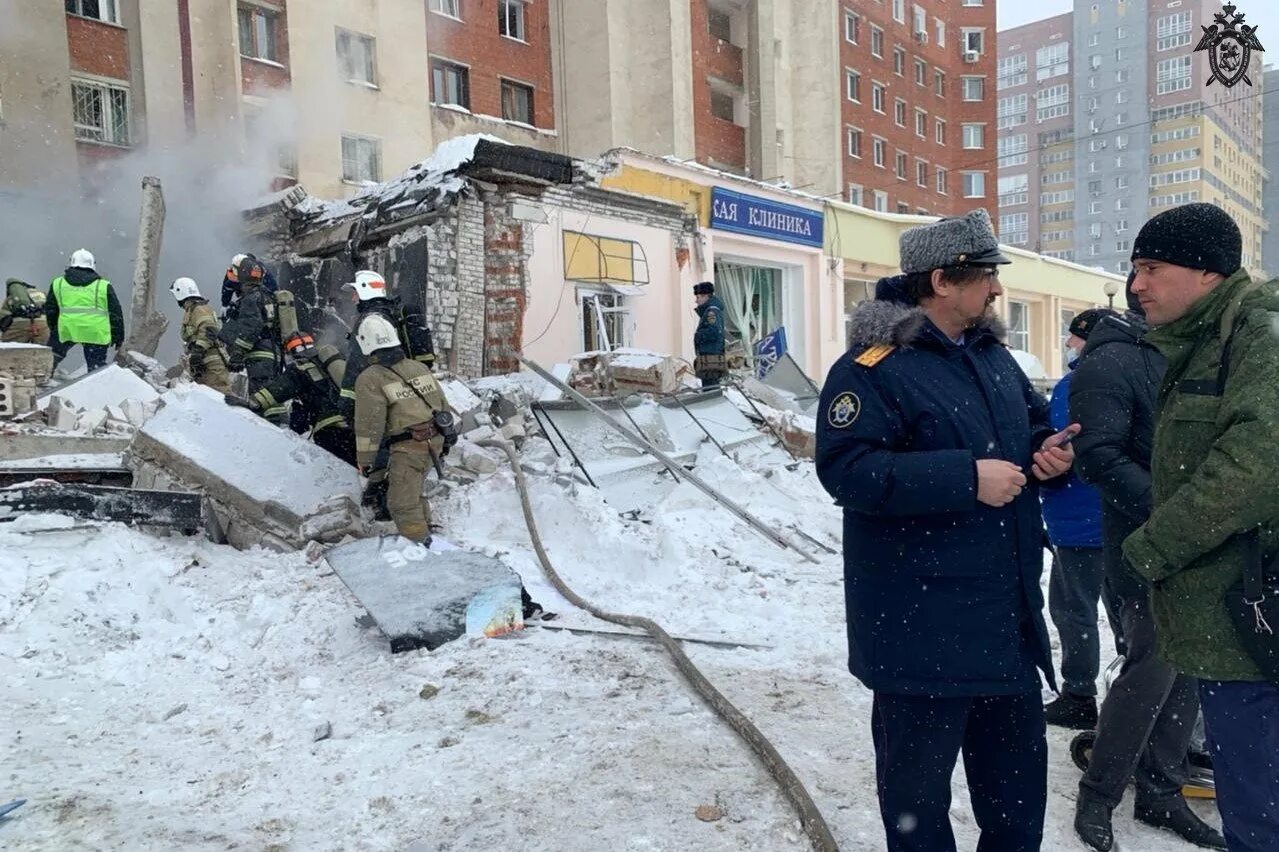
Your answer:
[999,0,1267,274]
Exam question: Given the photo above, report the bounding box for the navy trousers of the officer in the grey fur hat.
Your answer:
[871,691,1048,852]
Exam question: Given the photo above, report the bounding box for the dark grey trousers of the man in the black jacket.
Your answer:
[1079,588,1198,807]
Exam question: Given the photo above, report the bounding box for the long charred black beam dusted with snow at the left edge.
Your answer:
[0,480,205,535]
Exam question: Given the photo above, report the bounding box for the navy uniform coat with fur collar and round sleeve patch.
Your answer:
[816,289,1055,696]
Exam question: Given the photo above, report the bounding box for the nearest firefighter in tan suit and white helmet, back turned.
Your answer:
[356,315,458,545]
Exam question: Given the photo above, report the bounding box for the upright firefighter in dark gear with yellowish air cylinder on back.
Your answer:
[217,257,289,426]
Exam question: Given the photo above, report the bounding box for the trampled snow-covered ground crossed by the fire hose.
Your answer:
[0,440,1216,852]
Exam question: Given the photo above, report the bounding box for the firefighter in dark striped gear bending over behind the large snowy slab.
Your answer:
[226,331,356,467]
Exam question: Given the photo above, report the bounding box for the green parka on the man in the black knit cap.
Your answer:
[1123,270,1279,681]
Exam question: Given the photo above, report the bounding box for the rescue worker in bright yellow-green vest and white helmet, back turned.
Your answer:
[45,248,124,371]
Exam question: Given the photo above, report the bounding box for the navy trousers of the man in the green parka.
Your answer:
[1200,681,1279,852]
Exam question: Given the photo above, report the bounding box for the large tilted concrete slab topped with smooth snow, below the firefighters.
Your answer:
[128,385,367,549]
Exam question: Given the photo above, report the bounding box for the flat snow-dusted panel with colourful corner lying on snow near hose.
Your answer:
[325,536,523,654]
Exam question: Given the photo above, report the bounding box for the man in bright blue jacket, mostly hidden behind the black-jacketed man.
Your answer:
[1042,308,1120,730]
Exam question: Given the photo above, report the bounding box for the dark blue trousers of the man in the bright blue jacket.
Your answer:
[1048,548,1123,696]
